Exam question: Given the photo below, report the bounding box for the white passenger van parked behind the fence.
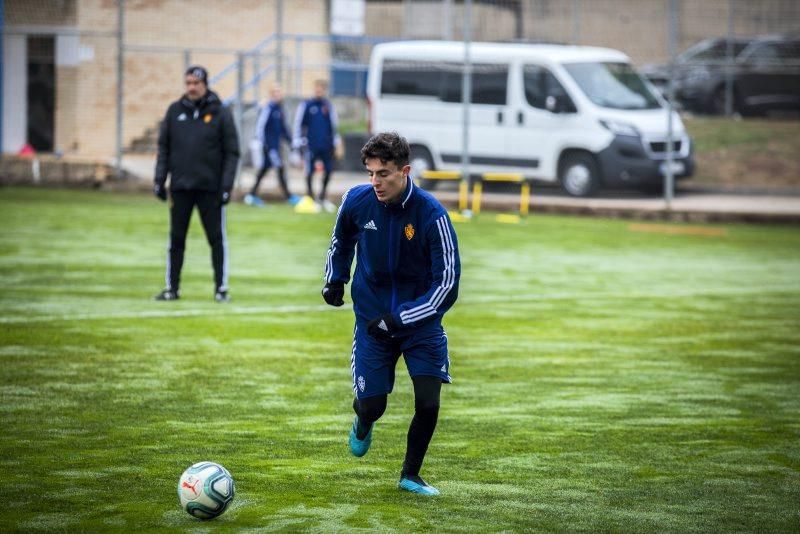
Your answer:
[367,41,694,196]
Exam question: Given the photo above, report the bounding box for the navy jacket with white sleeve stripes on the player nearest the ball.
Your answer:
[325,178,461,335]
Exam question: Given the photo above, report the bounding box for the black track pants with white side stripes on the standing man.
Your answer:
[166,190,228,291]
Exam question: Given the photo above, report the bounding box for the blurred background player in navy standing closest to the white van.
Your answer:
[292,80,342,212]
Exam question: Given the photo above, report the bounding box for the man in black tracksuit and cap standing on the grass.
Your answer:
[153,67,239,302]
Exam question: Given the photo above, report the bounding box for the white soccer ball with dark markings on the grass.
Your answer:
[178,462,235,519]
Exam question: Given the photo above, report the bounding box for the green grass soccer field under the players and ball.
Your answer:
[0,188,800,532]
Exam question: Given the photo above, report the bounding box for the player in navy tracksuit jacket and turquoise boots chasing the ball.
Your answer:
[322,133,461,495]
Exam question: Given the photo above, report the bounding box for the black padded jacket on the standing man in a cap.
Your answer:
[155,91,239,192]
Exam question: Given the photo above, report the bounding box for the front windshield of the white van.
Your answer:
[564,63,661,109]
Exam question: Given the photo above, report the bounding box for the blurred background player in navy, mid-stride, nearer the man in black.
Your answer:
[244,85,300,206]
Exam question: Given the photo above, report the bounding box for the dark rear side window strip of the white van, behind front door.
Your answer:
[381,60,508,106]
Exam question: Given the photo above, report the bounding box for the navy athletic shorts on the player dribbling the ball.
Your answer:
[350,323,452,399]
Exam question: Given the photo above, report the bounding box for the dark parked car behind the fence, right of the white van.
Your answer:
[642,36,800,115]
